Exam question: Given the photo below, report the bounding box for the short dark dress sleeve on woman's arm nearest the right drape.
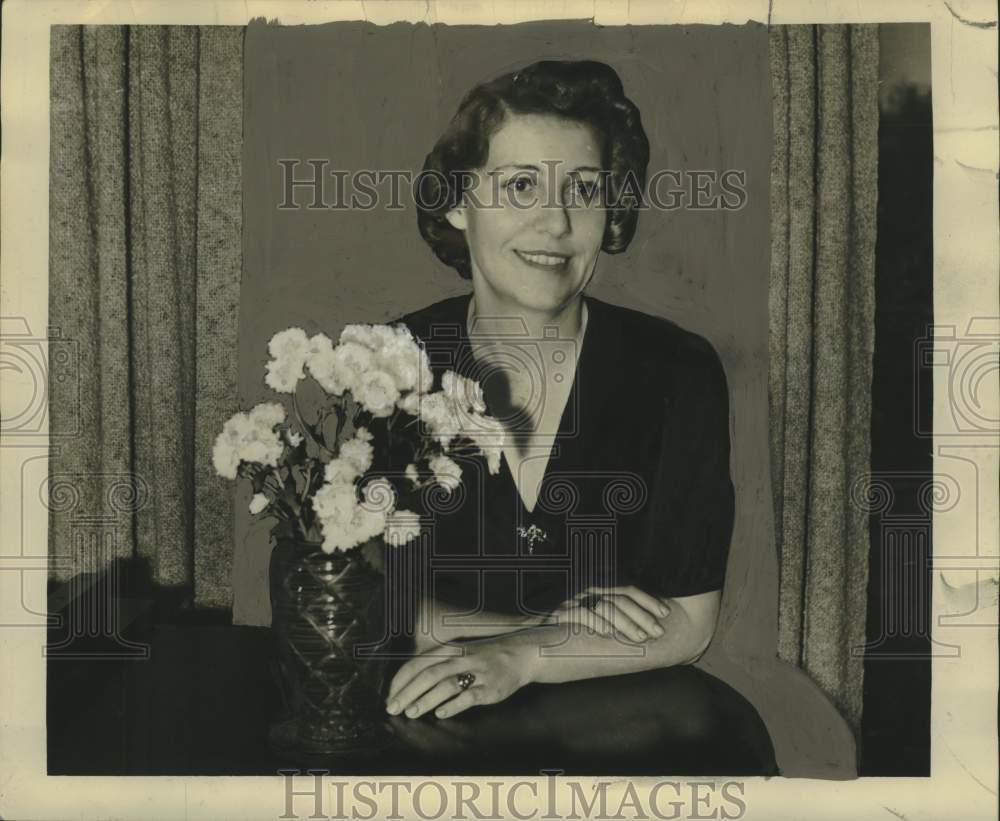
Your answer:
[632,335,735,596]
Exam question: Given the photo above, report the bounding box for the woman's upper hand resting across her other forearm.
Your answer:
[551,586,670,642]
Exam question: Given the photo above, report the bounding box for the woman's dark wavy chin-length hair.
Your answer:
[416,60,649,279]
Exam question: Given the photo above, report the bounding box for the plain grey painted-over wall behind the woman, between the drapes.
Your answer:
[234,21,777,666]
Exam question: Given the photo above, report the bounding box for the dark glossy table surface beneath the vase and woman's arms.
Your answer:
[48,624,777,776]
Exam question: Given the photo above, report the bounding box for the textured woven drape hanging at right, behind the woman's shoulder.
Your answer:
[770,25,878,733]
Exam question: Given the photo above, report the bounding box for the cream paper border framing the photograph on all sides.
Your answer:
[0,0,1000,821]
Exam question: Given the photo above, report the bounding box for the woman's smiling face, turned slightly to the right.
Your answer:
[448,114,606,311]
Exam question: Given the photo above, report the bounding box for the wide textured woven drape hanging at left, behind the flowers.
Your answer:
[49,26,243,607]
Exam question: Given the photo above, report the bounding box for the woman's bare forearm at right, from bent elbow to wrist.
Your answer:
[503,599,718,684]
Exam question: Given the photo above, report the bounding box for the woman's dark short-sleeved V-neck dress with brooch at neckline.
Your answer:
[395,294,734,613]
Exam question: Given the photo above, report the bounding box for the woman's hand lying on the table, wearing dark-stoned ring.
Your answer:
[386,636,537,718]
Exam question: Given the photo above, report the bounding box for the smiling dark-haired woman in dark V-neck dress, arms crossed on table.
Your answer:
[387,61,734,732]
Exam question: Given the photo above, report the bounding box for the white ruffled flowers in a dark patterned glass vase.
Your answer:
[213,324,504,753]
